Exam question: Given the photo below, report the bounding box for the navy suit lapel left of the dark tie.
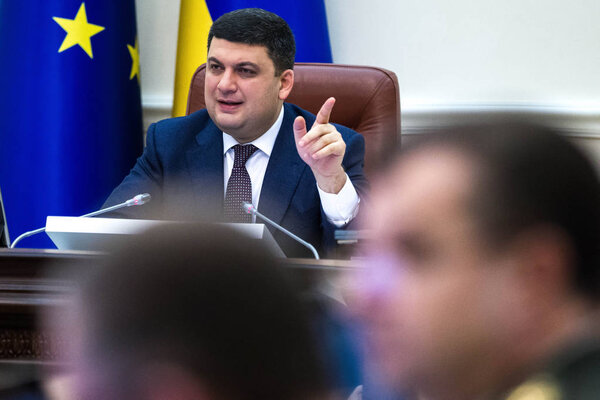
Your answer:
[186,123,224,215]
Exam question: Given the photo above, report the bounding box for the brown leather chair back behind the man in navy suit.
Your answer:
[187,63,400,176]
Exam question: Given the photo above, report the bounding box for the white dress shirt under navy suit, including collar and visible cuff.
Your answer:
[223,107,360,228]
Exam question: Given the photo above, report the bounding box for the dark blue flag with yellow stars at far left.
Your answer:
[0,0,143,248]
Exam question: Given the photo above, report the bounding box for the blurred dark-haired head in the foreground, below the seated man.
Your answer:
[49,226,331,400]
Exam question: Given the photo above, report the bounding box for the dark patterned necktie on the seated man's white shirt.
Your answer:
[224,144,258,222]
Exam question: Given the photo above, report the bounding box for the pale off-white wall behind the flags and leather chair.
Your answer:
[136,0,600,165]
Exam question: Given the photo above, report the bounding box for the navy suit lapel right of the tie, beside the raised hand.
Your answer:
[258,104,306,223]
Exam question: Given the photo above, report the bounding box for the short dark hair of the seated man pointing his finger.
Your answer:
[208,8,296,75]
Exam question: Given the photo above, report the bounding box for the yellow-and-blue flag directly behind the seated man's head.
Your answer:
[173,0,331,116]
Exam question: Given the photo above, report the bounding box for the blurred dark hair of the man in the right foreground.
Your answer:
[404,122,600,300]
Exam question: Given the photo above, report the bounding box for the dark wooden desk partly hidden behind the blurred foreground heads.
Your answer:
[0,249,358,361]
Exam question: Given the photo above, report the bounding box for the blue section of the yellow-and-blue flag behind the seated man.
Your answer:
[206,0,331,63]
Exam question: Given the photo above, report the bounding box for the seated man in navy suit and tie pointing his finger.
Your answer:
[105,9,367,256]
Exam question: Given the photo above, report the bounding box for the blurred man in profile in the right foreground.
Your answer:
[352,123,600,400]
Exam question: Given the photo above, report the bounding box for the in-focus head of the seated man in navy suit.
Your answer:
[204,8,296,143]
